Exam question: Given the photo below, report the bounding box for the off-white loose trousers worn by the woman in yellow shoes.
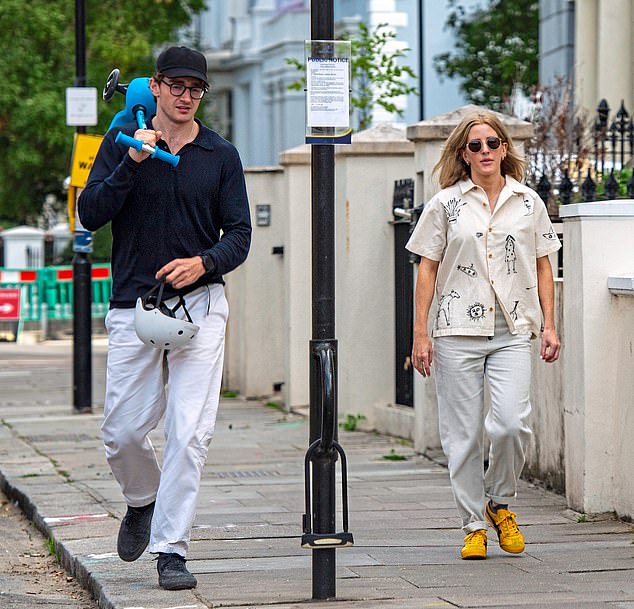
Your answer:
[434,307,531,533]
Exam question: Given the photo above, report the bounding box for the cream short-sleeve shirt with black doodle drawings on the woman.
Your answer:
[406,176,561,336]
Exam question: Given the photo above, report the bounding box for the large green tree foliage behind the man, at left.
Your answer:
[0,0,204,223]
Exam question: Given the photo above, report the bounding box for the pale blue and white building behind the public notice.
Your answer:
[191,0,484,166]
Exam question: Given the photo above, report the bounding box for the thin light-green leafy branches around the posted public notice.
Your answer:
[286,22,418,130]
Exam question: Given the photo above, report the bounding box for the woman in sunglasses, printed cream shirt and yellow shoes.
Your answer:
[407,112,561,559]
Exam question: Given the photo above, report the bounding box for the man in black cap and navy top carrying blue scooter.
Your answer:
[79,47,251,590]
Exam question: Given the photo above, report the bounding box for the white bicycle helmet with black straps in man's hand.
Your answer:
[134,280,200,349]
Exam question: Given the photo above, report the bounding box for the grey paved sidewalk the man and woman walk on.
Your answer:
[0,339,634,609]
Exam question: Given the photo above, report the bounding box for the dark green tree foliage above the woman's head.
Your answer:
[434,0,539,110]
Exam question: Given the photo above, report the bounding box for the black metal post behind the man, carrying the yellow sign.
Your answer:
[73,0,92,413]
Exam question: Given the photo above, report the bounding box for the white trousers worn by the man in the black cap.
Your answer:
[101,284,228,556]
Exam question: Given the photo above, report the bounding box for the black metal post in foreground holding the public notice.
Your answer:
[310,0,337,600]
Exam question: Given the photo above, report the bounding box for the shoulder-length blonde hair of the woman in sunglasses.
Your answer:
[433,111,524,188]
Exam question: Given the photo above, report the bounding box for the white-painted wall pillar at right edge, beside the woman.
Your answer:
[560,201,634,517]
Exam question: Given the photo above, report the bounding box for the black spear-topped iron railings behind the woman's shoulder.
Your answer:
[527,99,634,216]
